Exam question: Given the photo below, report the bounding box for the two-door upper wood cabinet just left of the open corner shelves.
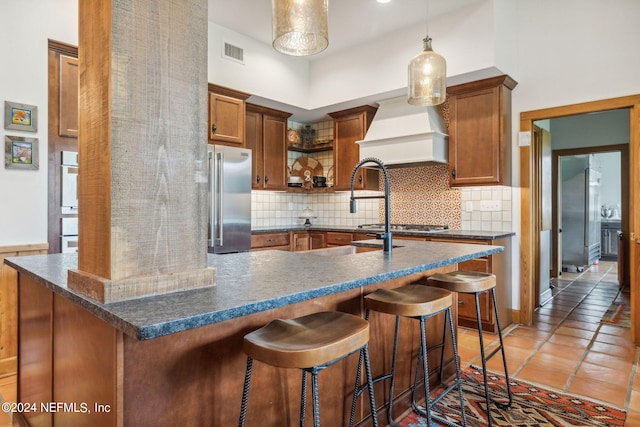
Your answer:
[245,104,291,190]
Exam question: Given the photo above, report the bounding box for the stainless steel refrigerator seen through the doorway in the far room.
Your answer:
[561,154,601,271]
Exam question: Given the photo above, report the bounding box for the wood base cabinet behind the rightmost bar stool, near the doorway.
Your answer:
[429,237,512,333]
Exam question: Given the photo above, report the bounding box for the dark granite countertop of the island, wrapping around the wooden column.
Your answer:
[5,240,504,340]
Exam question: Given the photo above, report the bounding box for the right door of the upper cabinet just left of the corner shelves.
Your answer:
[262,114,287,190]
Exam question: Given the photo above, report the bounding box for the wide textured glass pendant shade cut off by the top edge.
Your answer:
[271,0,329,56]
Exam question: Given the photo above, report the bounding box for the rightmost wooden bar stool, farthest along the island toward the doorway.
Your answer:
[427,271,513,427]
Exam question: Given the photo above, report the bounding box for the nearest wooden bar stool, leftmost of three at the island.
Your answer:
[239,311,378,427]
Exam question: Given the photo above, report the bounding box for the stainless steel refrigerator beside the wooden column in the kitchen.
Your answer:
[208,144,251,254]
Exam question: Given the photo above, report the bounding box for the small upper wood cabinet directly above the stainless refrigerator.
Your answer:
[209,83,250,147]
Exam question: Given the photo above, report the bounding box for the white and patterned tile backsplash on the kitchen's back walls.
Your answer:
[251,120,512,231]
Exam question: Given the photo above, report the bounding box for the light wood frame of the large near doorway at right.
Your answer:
[519,95,640,345]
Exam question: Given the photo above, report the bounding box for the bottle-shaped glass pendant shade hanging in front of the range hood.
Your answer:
[407,36,447,105]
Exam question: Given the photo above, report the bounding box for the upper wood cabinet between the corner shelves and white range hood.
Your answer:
[329,105,378,190]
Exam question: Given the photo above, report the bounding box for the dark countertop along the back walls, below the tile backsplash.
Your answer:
[251,225,516,240]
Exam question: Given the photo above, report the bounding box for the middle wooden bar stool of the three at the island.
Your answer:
[356,285,466,427]
